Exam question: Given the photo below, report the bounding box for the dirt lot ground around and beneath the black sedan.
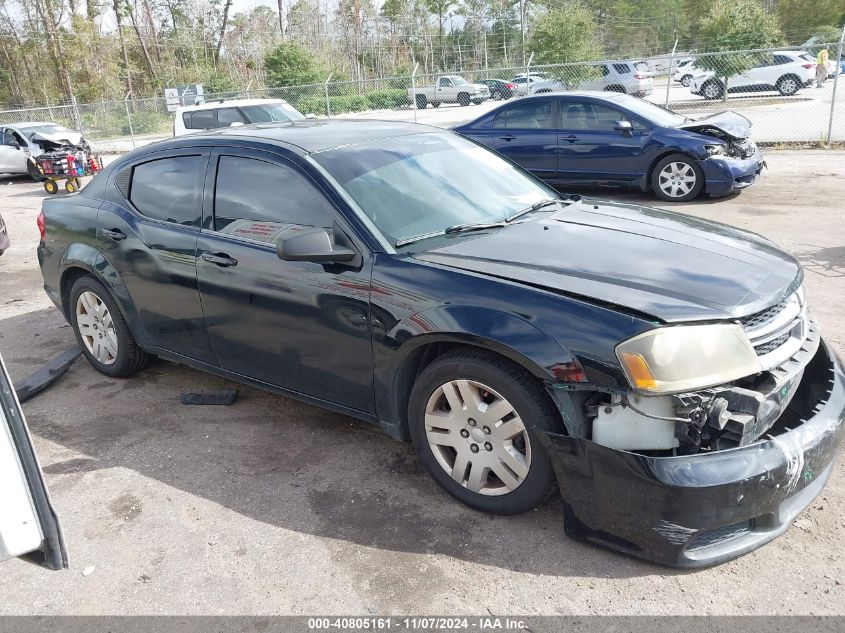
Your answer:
[0,152,845,615]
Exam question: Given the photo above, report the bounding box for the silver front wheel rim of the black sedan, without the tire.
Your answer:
[425,380,531,495]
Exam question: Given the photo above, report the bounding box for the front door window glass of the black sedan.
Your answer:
[214,156,334,241]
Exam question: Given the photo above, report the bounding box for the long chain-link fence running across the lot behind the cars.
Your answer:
[0,42,845,153]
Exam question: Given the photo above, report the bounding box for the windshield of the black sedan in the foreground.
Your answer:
[312,132,560,244]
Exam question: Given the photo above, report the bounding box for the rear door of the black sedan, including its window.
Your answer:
[97,148,214,363]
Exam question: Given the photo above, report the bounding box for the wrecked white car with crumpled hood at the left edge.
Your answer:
[0,121,85,181]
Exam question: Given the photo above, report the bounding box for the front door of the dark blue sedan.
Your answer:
[558,99,649,182]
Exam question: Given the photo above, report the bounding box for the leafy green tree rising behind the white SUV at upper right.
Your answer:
[695,0,782,77]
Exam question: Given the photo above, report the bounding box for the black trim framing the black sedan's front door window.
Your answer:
[200,145,372,259]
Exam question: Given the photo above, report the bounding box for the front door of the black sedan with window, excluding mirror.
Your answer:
[197,149,374,413]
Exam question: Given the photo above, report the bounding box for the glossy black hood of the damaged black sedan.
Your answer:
[414,201,802,322]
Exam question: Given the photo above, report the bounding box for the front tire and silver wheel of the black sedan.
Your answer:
[408,350,563,514]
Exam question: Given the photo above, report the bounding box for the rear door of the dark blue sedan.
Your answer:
[492,97,558,180]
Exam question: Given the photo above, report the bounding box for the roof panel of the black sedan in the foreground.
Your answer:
[159,119,436,154]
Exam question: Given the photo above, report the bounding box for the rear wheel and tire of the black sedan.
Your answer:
[69,275,153,378]
